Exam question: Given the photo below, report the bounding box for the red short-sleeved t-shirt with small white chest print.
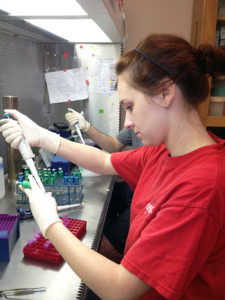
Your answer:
[111,136,225,300]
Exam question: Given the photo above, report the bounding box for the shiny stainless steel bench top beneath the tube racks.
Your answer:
[0,175,115,300]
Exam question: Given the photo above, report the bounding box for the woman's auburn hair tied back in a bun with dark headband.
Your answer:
[116,34,225,105]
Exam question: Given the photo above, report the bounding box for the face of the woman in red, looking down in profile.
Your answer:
[118,73,166,146]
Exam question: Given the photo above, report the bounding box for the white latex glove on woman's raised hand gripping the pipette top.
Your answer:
[0,109,60,153]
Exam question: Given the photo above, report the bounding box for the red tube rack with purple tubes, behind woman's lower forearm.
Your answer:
[23,217,87,264]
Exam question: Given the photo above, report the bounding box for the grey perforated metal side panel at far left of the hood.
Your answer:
[0,33,47,172]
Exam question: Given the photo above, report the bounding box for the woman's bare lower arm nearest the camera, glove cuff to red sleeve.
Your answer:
[46,222,150,300]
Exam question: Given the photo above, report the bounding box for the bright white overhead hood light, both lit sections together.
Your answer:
[0,0,112,43]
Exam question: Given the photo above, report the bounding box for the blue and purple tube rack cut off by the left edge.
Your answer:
[0,214,20,261]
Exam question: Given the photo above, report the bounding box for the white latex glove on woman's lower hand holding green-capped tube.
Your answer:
[20,175,62,238]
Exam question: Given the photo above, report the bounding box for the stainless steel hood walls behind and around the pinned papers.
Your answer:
[0,31,120,176]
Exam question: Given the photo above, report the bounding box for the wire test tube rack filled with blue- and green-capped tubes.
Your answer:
[16,166,84,205]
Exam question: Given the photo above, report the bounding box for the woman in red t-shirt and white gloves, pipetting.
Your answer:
[1,34,225,300]
